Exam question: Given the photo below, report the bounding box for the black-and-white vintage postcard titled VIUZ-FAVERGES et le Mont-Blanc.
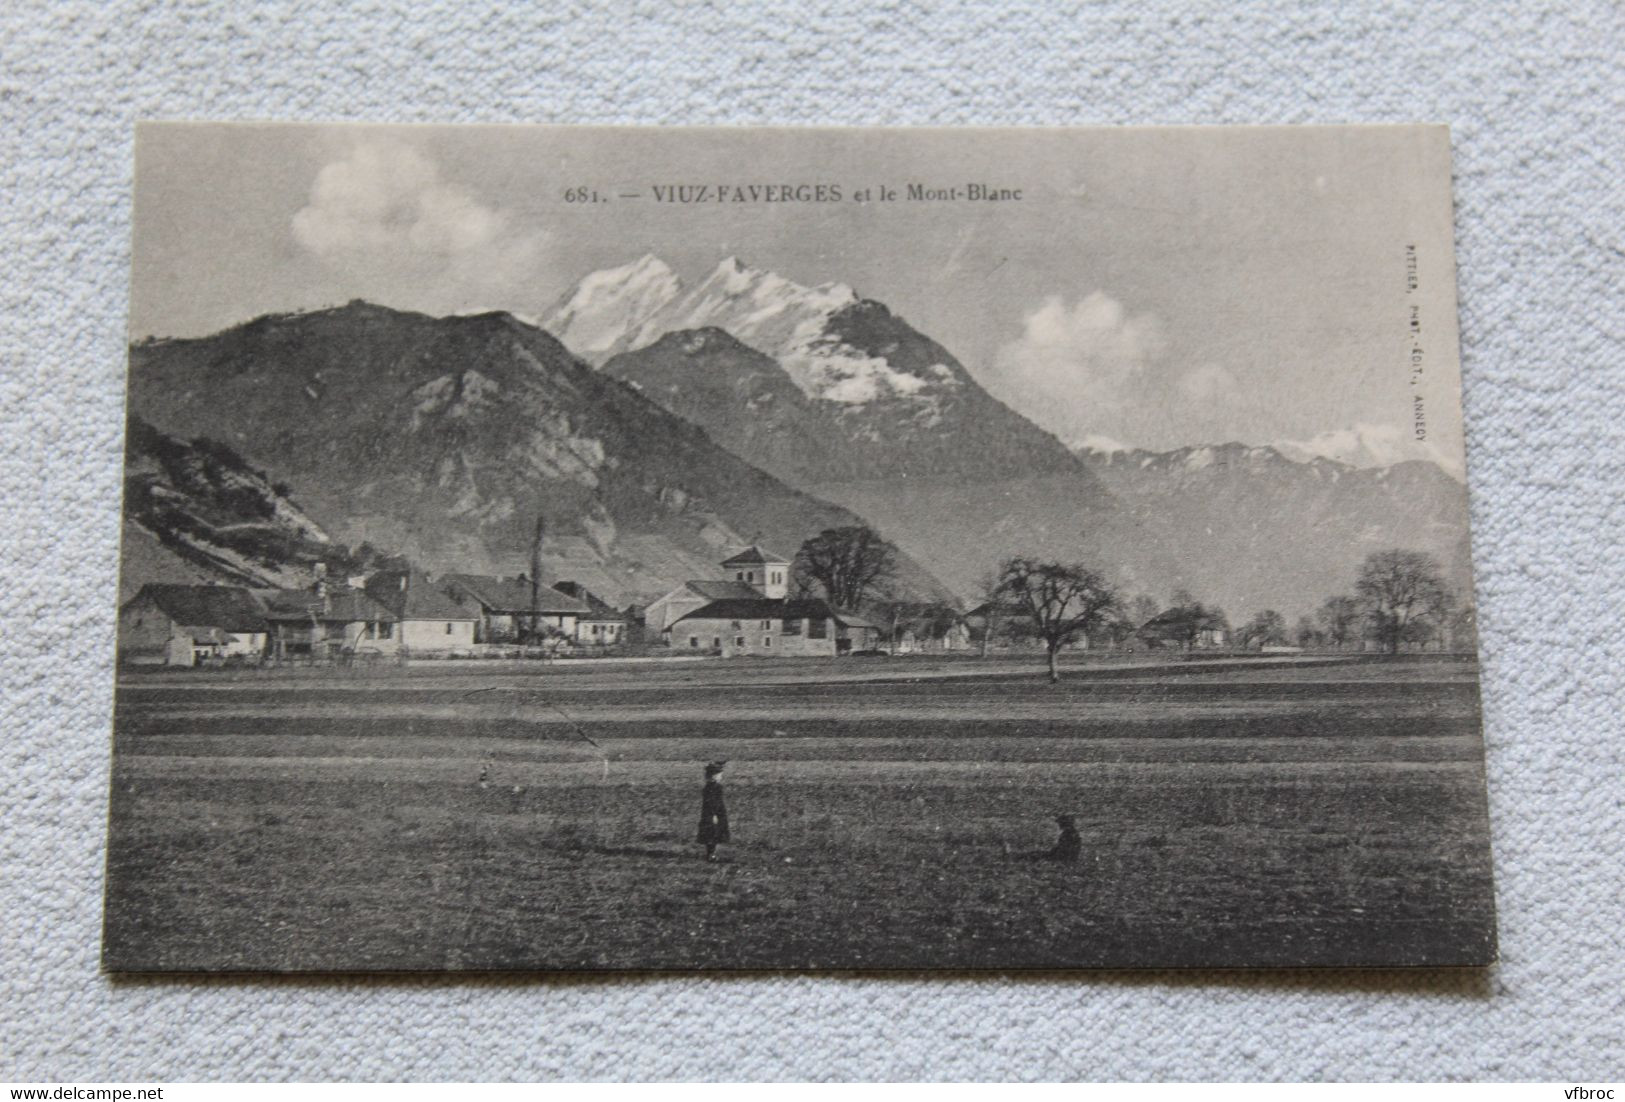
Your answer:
[102,124,1497,972]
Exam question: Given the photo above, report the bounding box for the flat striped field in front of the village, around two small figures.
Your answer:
[104,658,1495,970]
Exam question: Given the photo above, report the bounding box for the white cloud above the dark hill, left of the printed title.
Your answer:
[293,141,541,293]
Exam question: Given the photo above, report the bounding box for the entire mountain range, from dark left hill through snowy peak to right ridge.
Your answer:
[127,257,1467,619]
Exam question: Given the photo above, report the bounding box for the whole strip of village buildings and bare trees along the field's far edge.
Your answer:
[119,533,1471,668]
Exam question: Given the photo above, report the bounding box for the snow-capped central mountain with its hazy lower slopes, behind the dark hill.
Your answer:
[543,257,1110,600]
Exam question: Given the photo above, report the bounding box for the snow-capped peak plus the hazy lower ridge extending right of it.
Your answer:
[544,257,1467,614]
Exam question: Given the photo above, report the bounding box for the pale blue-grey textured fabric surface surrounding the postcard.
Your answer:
[0,0,1625,1081]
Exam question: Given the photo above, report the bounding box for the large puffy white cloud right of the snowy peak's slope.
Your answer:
[988,291,1167,442]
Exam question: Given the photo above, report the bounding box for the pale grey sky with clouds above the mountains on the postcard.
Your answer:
[130,124,1461,473]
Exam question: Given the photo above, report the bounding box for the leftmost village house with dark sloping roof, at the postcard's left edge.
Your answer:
[119,584,270,666]
